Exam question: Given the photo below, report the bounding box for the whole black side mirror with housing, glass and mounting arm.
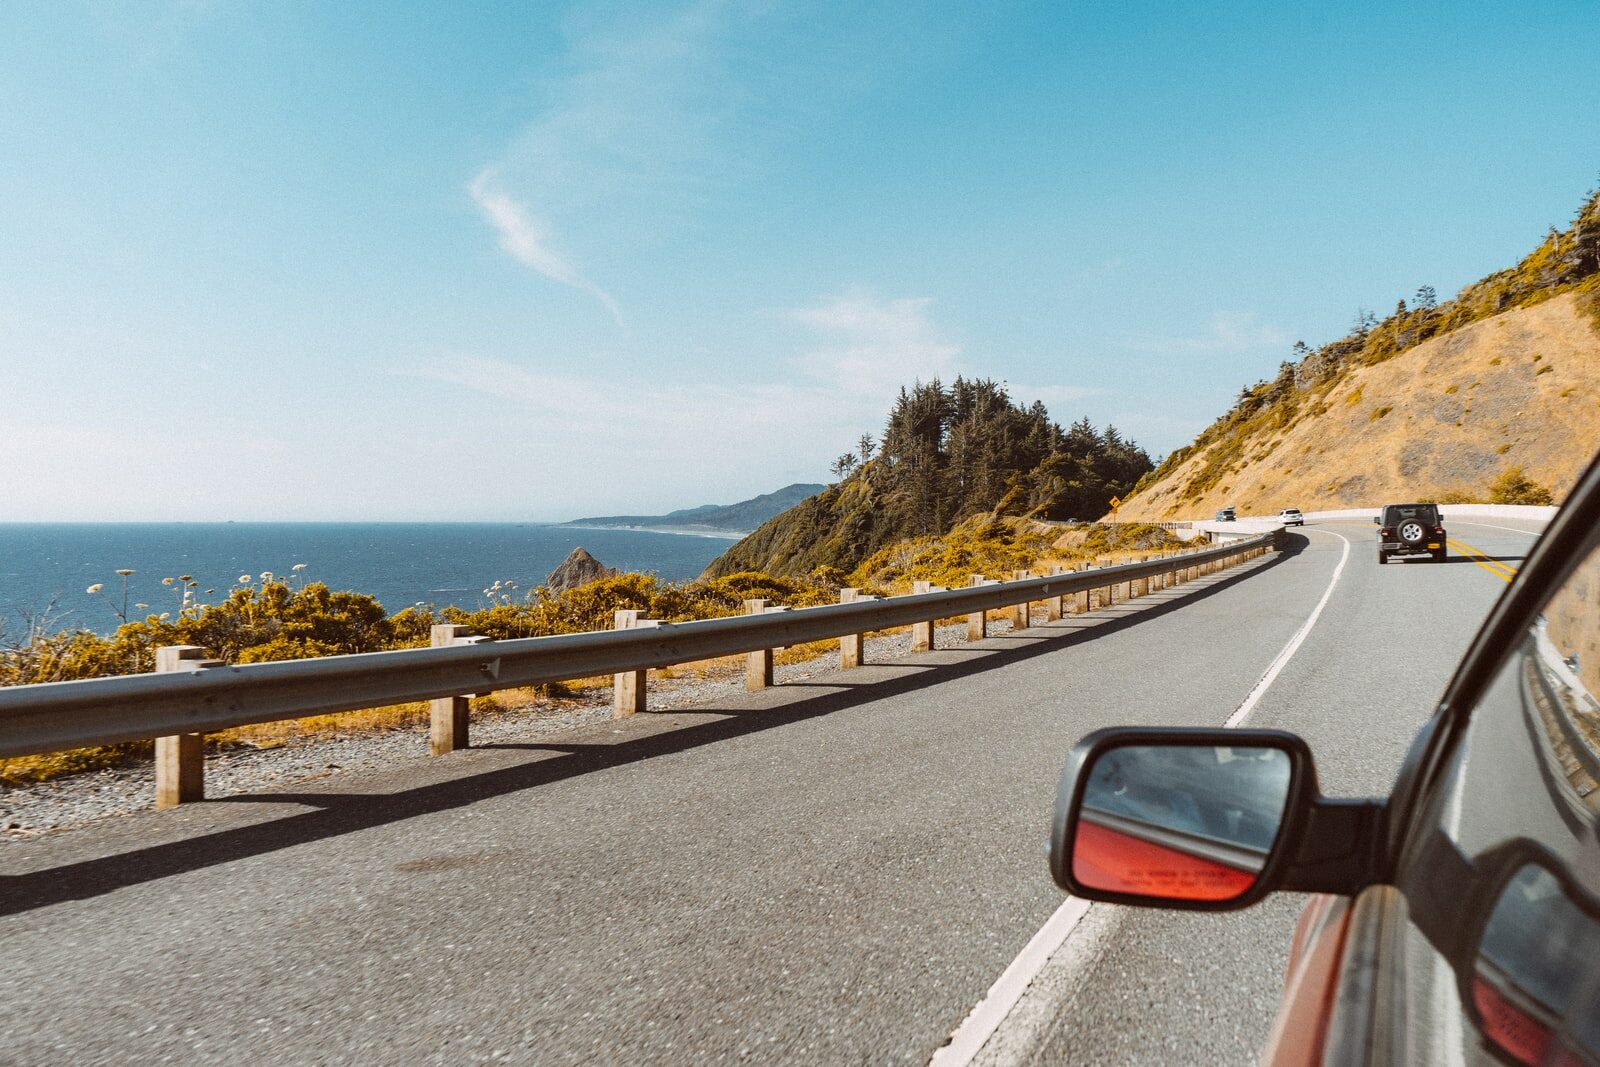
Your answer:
[1050,728,1381,910]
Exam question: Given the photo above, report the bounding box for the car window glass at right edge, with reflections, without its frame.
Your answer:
[1397,524,1600,1064]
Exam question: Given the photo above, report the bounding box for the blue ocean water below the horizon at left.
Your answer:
[0,523,733,637]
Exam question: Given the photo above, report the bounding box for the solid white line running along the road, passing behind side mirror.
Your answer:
[928,530,1350,1067]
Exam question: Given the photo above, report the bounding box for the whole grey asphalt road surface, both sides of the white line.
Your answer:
[0,523,1530,1064]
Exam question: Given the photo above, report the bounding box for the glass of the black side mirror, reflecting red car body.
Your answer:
[1072,745,1291,901]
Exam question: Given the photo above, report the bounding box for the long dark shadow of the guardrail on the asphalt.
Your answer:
[0,534,1309,915]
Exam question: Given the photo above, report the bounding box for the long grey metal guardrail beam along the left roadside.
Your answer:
[0,533,1275,803]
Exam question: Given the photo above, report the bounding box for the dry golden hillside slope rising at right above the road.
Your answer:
[1118,194,1600,522]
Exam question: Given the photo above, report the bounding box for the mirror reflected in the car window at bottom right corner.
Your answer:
[1470,864,1600,1065]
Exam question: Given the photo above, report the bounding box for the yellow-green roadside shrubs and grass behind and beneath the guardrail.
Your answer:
[0,515,1179,785]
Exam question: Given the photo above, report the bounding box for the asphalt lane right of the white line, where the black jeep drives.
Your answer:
[979,522,1534,1064]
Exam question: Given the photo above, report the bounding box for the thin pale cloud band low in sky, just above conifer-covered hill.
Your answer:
[416,290,1091,502]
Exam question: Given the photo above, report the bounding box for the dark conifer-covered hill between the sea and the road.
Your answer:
[706,378,1154,577]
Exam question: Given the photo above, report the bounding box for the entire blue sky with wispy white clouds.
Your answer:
[0,0,1600,520]
